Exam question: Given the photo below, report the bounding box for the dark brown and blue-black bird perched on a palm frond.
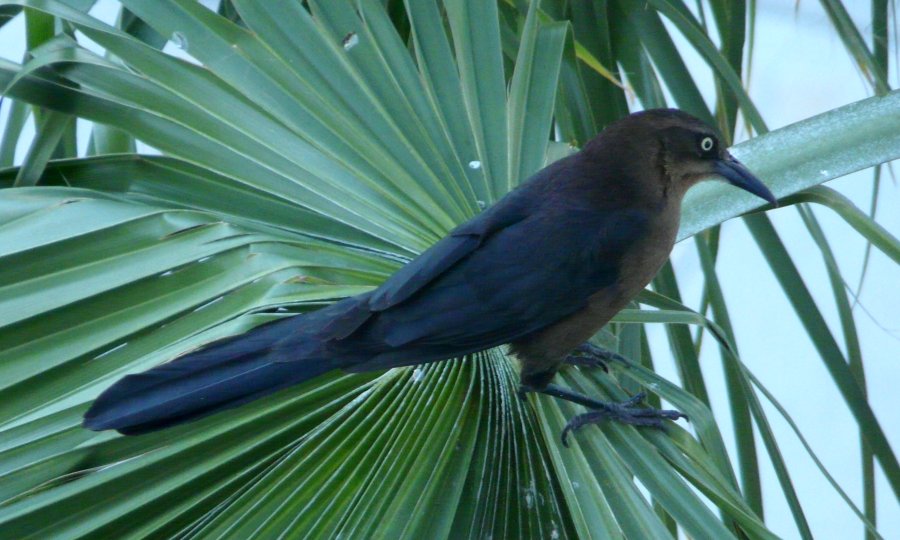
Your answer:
[84,109,775,441]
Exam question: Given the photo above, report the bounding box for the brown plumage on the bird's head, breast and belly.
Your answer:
[511,110,748,389]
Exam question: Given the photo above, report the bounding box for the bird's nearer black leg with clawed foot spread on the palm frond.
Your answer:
[519,384,687,447]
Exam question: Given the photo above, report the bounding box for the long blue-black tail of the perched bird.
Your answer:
[84,316,344,435]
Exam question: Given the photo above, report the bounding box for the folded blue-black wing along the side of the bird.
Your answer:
[349,202,647,371]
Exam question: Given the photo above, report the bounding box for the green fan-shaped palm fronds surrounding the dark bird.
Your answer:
[0,0,900,538]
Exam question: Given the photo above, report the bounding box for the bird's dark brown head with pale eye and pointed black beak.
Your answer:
[607,109,775,204]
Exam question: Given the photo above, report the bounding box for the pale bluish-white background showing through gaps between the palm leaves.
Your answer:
[0,0,900,539]
